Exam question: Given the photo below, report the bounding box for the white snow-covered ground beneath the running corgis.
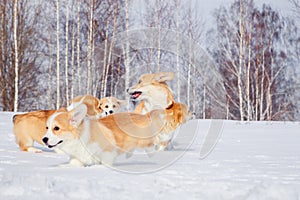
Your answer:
[0,112,300,200]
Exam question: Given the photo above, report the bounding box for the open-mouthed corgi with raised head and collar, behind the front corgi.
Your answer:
[127,72,192,150]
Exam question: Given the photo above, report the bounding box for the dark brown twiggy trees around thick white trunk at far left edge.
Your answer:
[0,0,41,111]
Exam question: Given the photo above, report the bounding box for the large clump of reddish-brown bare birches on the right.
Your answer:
[209,0,292,120]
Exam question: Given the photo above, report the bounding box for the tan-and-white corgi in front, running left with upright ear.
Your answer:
[43,104,166,166]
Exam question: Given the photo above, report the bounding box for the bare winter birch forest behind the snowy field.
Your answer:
[0,0,300,121]
